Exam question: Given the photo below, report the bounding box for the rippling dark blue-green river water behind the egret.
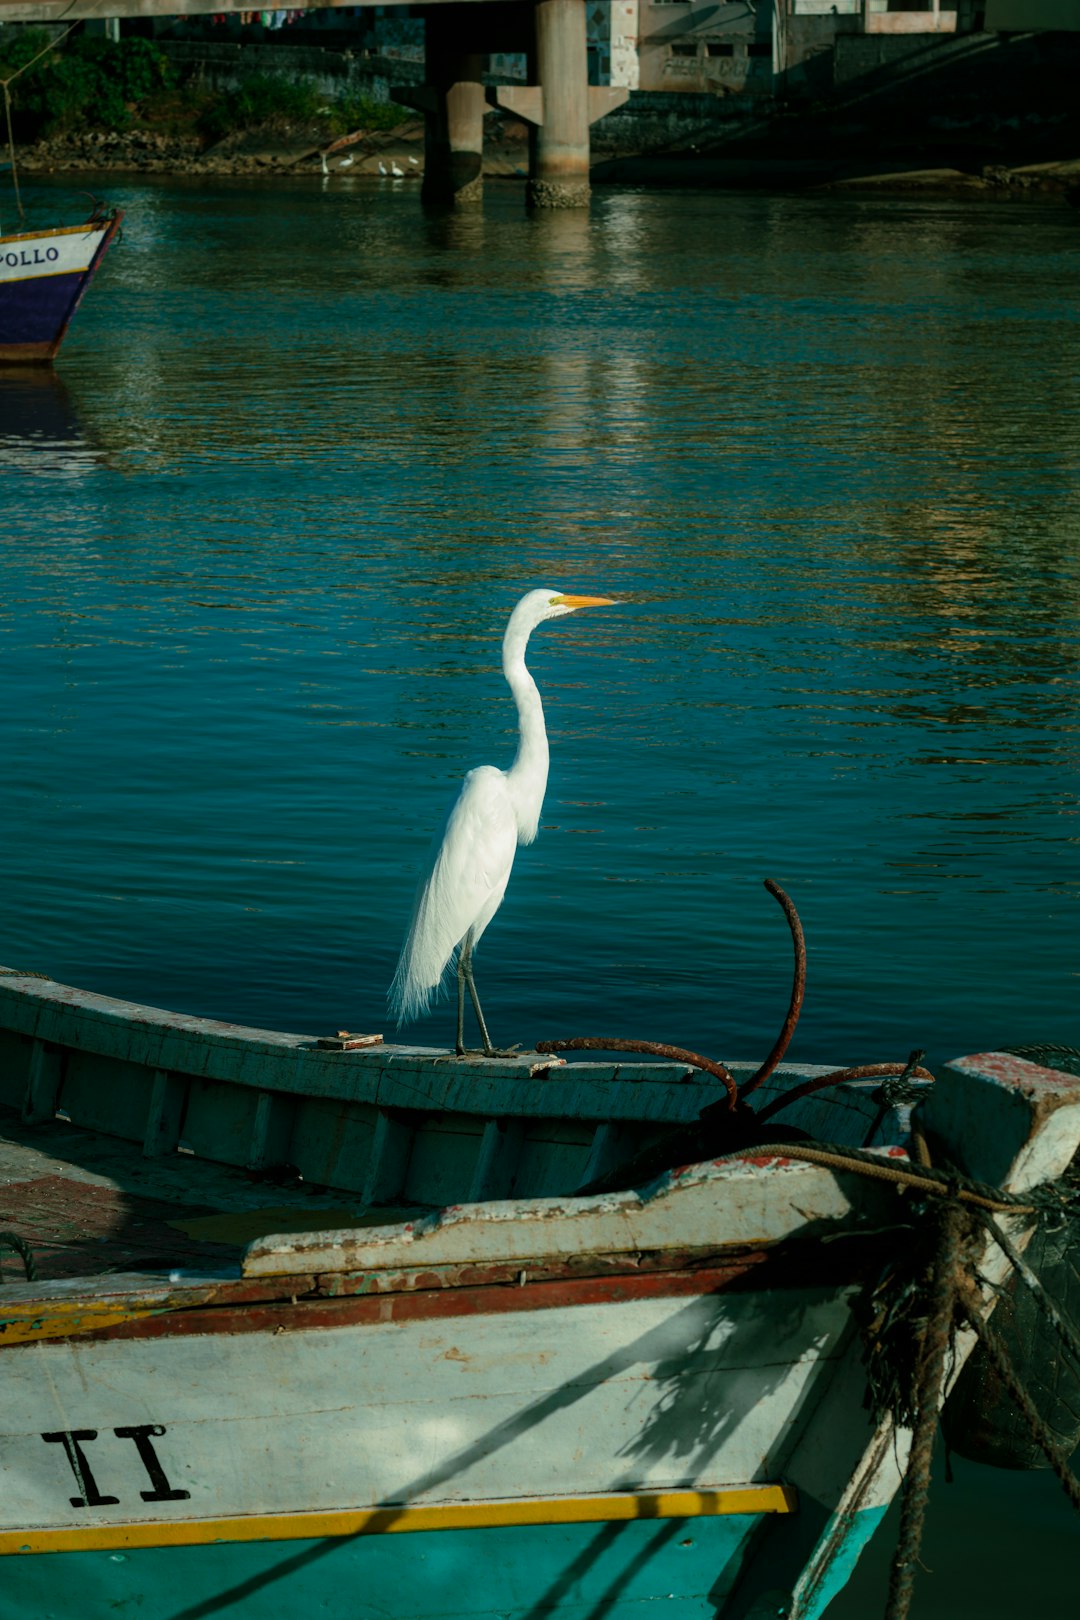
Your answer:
[0,170,1080,1620]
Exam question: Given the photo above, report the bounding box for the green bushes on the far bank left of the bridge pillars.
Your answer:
[0,29,411,144]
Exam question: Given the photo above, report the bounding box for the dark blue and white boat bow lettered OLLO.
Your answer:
[0,209,123,366]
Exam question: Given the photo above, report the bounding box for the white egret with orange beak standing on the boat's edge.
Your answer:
[390,588,614,1058]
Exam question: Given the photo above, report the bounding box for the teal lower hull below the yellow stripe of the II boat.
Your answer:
[8,1515,761,1620]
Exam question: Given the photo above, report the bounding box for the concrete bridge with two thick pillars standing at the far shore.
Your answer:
[0,0,628,207]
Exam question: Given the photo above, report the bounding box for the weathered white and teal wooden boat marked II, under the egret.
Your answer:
[0,969,1080,1620]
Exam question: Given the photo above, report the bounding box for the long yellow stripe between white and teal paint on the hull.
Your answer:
[0,1486,795,1554]
